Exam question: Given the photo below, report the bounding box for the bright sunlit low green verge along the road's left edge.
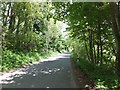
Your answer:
[0,50,57,72]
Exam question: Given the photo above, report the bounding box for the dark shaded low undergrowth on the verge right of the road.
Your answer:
[72,55,120,90]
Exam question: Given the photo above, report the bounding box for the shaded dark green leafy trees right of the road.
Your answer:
[53,2,120,79]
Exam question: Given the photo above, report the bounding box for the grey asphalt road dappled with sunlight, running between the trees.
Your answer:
[1,54,78,88]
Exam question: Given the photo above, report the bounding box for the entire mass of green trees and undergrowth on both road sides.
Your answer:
[0,2,120,88]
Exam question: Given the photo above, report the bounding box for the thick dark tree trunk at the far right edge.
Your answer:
[110,2,120,76]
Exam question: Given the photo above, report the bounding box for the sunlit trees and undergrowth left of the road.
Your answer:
[0,2,68,71]
